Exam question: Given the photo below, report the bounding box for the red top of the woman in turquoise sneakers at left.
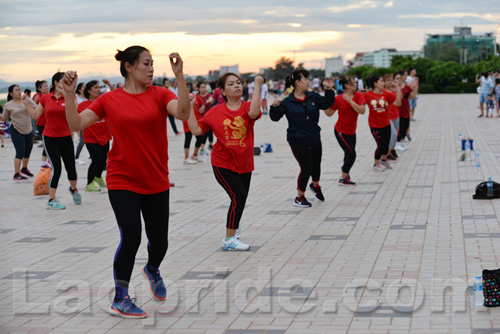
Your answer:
[38,93,71,137]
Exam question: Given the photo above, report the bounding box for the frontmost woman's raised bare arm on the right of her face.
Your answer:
[167,52,190,121]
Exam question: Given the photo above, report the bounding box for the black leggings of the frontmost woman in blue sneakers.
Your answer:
[108,190,170,288]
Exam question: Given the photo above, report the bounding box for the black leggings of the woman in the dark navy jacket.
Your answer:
[290,142,323,192]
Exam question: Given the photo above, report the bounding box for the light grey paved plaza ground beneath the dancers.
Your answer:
[0,94,500,334]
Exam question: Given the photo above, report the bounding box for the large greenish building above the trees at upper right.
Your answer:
[424,27,496,64]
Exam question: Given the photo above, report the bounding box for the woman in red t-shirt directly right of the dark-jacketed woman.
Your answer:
[325,75,366,186]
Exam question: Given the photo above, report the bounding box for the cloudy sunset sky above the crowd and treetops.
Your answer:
[0,0,500,83]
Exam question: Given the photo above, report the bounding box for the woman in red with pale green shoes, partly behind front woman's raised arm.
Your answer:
[78,79,115,192]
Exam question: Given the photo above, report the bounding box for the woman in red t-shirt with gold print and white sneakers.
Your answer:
[188,73,264,251]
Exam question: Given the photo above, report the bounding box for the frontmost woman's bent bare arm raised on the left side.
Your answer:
[62,71,99,132]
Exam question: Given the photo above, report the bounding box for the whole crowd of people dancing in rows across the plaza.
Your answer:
[6,46,492,318]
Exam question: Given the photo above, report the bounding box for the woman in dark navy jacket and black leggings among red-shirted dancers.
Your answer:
[270,70,335,208]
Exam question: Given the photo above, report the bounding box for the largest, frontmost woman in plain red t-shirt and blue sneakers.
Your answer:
[60,46,190,318]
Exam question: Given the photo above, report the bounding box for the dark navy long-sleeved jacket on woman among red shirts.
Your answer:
[269,90,335,146]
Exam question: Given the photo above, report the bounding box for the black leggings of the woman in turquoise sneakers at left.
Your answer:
[42,135,77,189]
